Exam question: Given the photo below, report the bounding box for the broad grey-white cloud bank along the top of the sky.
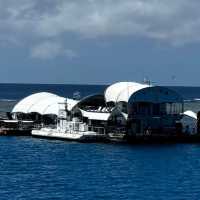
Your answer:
[0,0,200,44]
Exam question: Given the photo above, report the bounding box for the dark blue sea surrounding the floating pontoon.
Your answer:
[0,84,200,200]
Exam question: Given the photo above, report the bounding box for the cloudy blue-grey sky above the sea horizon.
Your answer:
[0,0,200,86]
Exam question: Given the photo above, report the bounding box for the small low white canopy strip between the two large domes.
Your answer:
[81,110,110,121]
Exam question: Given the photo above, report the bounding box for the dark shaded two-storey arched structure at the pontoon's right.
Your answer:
[128,86,184,135]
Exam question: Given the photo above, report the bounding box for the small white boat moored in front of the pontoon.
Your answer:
[32,121,106,142]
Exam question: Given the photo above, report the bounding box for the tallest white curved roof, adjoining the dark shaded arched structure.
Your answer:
[105,82,150,102]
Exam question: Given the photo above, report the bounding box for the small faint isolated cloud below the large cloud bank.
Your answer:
[31,41,77,60]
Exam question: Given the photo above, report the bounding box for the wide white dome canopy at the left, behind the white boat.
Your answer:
[12,92,78,115]
